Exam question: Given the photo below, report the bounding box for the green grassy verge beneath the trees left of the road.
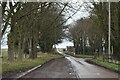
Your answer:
[2,49,63,73]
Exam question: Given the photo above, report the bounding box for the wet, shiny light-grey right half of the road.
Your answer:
[66,56,118,78]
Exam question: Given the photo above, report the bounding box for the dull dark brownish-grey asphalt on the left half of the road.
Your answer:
[22,58,76,78]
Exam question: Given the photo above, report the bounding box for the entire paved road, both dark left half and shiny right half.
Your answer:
[20,51,118,80]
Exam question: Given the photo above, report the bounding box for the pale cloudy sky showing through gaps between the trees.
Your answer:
[1,0,89,48]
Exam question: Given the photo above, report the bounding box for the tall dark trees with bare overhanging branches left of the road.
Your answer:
[1,1,81,61]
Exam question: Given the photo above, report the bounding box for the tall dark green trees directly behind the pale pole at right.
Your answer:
[93,2,120,59]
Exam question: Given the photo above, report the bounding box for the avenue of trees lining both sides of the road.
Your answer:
[0,1,120,61]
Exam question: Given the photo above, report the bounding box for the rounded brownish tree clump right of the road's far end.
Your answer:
[69,18,102,54]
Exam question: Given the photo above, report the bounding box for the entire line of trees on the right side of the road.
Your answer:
[69,2,120,60]
